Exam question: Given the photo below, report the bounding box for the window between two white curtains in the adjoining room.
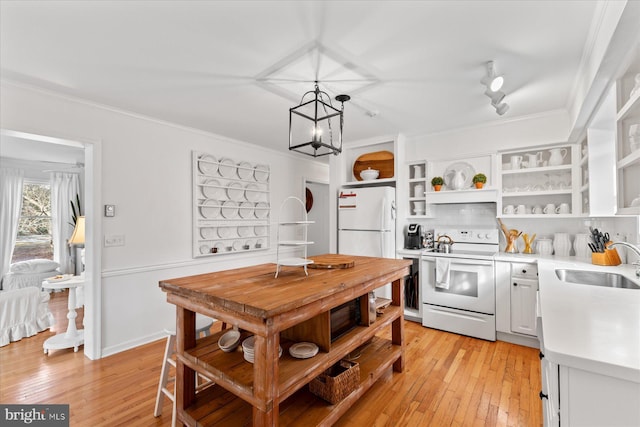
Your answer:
[11,180,53,263]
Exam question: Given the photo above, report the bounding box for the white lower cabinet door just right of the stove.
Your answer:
[511,277,538,336]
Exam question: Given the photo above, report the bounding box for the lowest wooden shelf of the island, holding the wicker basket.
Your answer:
[181,336,402,426]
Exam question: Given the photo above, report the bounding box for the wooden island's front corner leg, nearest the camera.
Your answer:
[253,333,280,427]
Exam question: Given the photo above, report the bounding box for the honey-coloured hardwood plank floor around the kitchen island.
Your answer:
[0,292,542,427]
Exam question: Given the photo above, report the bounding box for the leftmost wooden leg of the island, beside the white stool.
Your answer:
[174,306,196,420]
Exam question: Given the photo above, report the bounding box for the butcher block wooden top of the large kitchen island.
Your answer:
[160,255,411,319]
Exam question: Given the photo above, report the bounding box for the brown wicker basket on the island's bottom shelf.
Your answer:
[309,360,360,404]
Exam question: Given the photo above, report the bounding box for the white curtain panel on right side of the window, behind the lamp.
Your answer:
[51,172,82,273]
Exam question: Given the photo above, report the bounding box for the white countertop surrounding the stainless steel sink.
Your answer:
[538,258,640,383]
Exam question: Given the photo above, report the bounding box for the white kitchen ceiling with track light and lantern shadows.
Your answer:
[0,0,602,157]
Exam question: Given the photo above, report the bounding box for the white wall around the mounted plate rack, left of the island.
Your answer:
[0,82,329,356]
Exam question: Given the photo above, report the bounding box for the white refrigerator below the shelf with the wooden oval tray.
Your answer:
[338,187,396,298]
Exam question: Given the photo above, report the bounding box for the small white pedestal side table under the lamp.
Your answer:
[42,276,84,354]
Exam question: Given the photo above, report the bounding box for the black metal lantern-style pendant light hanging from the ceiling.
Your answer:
[289,82,351,157]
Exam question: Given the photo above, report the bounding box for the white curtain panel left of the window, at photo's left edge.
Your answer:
[0,168,24,279]
